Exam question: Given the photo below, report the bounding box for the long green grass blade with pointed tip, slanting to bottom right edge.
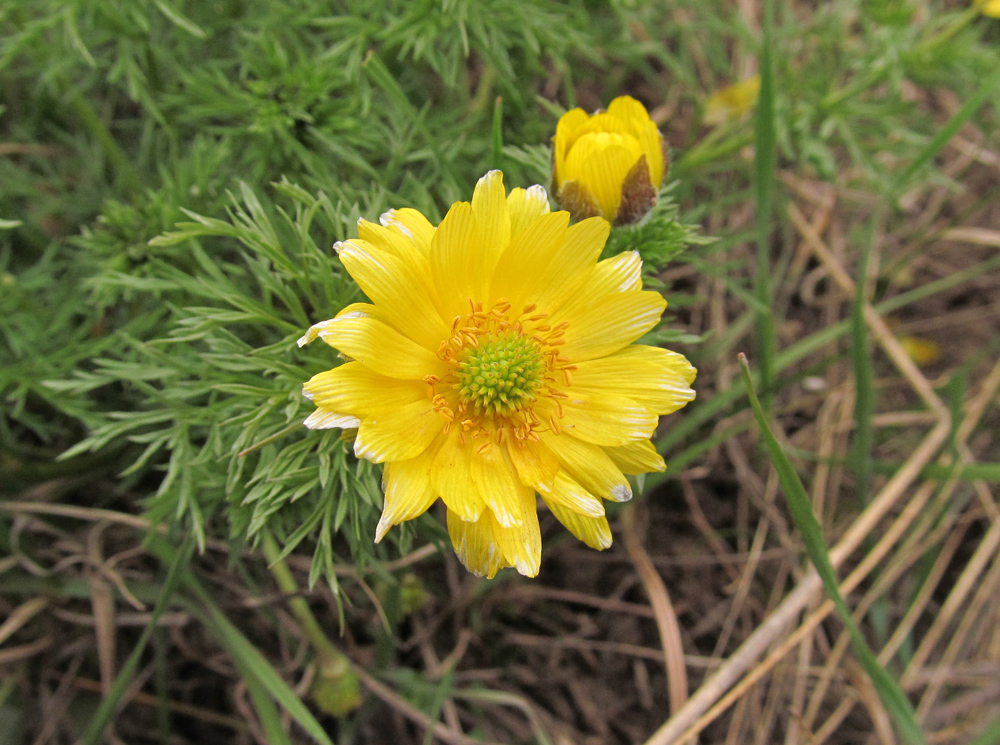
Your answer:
[740,354,924,745]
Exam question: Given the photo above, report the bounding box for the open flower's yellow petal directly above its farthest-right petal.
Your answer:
[562,292,667,362]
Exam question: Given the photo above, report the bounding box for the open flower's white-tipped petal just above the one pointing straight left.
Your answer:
[317,316,446,380]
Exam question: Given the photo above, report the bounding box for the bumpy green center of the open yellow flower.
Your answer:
[457,330,545,416]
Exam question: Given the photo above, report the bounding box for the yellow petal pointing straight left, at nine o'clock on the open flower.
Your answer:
[302,362,427,416]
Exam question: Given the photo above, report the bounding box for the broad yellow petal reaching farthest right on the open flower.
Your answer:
[572,345,697,414]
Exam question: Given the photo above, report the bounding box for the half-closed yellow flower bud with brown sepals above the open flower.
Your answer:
[552,96,667,225]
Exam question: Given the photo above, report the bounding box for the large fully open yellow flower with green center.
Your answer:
[299,171,695,577]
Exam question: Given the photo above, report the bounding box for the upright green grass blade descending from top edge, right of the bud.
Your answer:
[754,0,777,410]
